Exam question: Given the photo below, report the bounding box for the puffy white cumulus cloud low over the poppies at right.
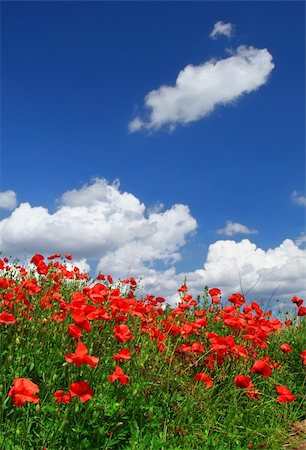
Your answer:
[136,239,306,308]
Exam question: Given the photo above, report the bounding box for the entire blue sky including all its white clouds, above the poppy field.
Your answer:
[0,1,306,308]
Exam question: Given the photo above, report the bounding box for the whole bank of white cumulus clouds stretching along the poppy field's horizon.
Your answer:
[0,179,306,305]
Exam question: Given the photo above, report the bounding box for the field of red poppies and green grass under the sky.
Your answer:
[0,254,306,450]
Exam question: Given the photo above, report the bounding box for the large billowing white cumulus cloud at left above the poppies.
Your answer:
[0,179,197,267]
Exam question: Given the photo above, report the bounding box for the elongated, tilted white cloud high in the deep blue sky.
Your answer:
[129,46,274,132]
